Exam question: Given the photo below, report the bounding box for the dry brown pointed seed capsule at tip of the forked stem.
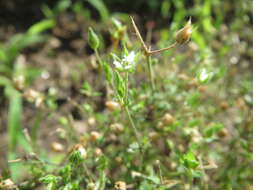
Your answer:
[176,19,192,44]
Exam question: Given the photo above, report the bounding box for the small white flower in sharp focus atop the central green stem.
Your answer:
[113,51,136,71]
